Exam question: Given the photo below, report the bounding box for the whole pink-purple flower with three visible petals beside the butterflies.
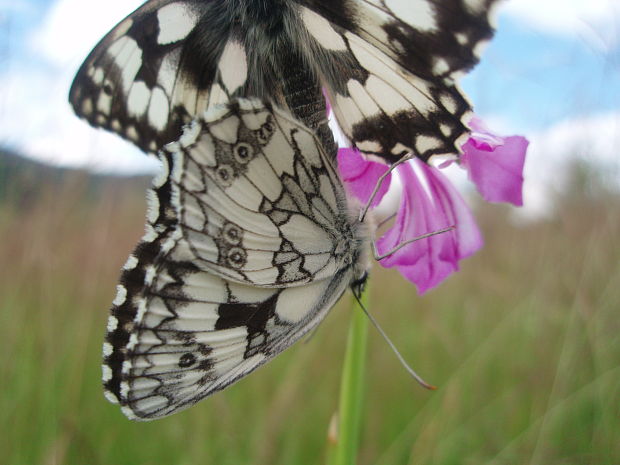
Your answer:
[338,119,528,294]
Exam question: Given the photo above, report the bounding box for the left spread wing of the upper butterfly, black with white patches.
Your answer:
[69,0,240,153]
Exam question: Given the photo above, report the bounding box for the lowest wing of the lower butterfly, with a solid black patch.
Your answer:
[103,236,350,420]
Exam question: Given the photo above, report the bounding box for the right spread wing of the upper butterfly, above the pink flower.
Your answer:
[300,0,497,162]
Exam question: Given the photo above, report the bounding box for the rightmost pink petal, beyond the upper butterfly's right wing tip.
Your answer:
[459,117,529,206]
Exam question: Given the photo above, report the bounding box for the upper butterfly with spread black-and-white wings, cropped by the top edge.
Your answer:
[70,0,496,163]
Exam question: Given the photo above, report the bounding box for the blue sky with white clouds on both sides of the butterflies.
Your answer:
[0,0,620,215]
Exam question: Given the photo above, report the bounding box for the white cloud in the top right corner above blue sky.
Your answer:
[502,0,620,49]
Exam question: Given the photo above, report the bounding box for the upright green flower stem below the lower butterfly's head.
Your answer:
[328,286,369,465]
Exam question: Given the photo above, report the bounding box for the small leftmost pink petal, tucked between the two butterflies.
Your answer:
[338,148,392,207]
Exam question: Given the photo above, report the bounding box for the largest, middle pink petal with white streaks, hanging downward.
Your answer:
[377,159,482,294]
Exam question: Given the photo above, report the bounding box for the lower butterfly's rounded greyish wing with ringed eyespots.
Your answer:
[166,100,354,286]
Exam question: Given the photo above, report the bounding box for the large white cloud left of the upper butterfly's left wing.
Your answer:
[0,0,157,173]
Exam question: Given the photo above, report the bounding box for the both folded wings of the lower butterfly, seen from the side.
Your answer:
[103,100,366,420]
